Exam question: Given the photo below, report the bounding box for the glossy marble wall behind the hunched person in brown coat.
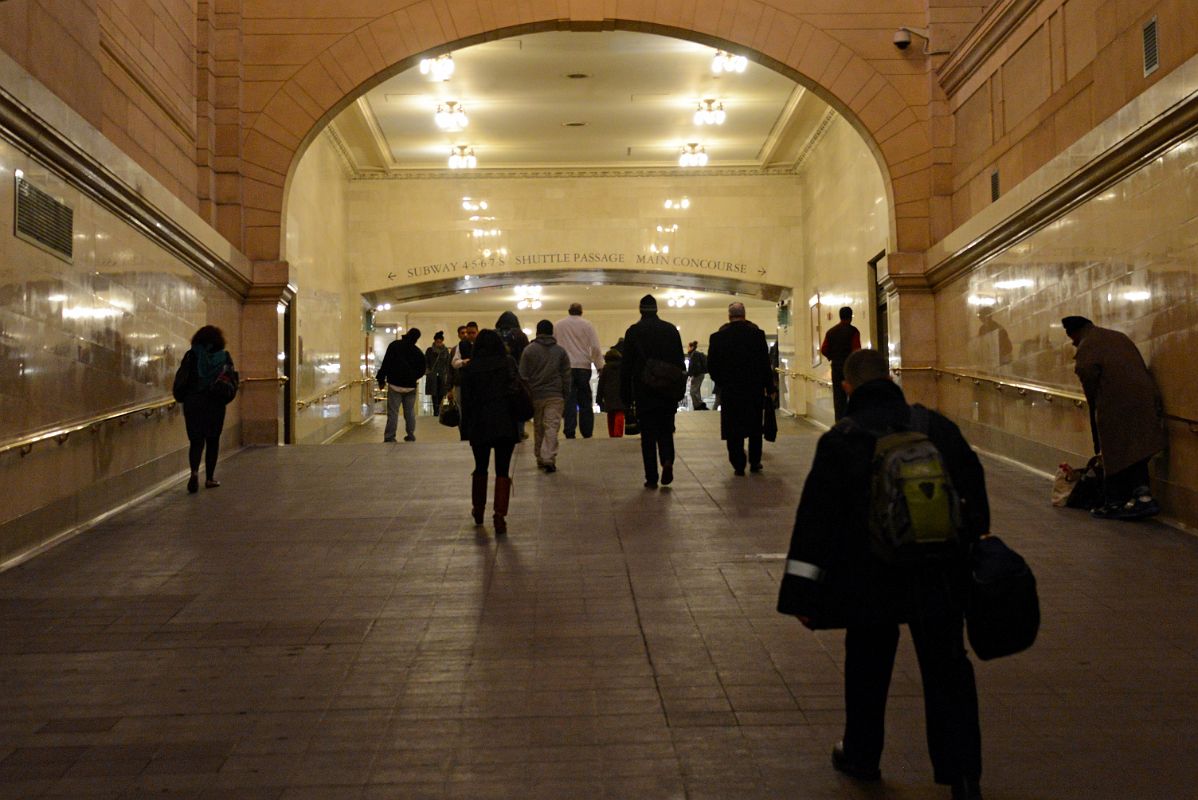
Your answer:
[937,129,1198,521]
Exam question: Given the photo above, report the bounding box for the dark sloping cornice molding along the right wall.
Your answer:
[927,92,1198,287]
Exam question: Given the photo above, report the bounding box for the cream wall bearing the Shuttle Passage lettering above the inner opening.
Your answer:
[342,176,801,291]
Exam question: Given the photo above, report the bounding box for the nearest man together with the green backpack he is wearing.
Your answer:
[778,350,990,800]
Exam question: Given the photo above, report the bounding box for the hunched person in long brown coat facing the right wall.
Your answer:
[1061,316,1164,520]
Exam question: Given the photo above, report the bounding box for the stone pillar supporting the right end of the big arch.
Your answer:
[878,253,939,408]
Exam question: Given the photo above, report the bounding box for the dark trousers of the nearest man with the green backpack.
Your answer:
[845,574,981,783]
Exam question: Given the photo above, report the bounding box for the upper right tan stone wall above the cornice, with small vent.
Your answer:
[940,0,1198,231]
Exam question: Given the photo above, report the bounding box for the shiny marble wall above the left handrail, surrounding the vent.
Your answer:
[0,141,240,440]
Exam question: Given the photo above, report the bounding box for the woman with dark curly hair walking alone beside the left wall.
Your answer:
[181,325,232,492]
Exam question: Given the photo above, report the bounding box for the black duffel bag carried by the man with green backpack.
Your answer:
[966,537,1040,661]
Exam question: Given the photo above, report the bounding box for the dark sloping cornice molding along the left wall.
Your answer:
[0,82,250,298]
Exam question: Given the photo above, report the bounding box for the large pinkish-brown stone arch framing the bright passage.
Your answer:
[233,0,937,441]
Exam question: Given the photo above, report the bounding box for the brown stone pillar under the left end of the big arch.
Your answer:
[241,261,295,444]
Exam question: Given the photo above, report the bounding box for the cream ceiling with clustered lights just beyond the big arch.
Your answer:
[333,31,827,175]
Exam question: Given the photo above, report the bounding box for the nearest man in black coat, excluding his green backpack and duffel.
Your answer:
[778,350,990,800]
